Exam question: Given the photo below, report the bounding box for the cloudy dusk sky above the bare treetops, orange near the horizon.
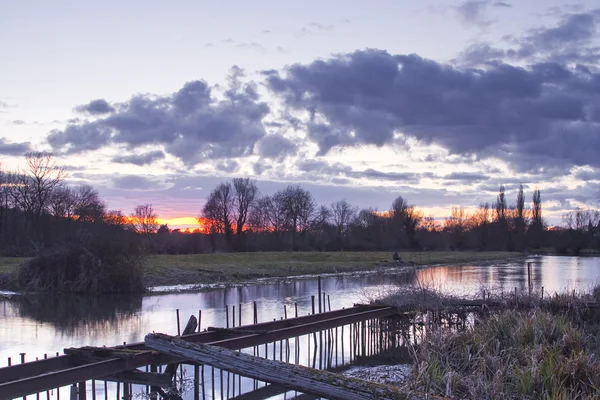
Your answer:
[0,0,600,227]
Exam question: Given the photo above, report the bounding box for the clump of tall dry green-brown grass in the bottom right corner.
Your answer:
[411,289,600,399]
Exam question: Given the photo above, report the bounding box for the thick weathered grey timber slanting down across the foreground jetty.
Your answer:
[145,333,416,400]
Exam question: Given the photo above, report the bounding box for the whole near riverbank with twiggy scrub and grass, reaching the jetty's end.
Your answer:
[381,286,600,399]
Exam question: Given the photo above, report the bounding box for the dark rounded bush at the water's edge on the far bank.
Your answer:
[17,235,145,293]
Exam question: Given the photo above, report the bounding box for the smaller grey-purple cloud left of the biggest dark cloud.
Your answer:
[48,67,269,166]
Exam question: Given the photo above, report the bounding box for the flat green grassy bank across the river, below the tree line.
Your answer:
[0,251,520,286]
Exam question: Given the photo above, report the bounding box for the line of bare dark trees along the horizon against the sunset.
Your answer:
[0,152,600,256]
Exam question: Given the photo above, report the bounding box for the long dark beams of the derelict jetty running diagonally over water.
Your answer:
[0,305,396,399]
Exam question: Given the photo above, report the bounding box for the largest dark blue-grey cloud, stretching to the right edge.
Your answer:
[266,49,600,171]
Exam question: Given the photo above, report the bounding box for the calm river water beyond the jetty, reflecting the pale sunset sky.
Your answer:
[0,256,600,398]
